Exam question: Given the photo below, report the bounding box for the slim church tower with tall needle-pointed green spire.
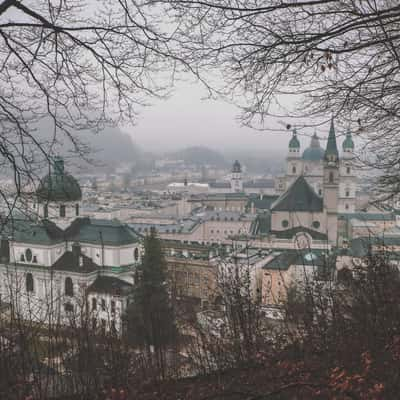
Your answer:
[323,118,339,245]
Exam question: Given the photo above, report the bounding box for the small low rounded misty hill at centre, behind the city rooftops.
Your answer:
[166,146,227,167]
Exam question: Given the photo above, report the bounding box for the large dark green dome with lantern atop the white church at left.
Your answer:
[36,157,82,202]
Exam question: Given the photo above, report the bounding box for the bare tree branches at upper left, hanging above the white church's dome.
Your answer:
[0,0,177,216]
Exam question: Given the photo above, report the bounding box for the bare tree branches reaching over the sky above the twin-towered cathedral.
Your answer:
[150,0,400,188]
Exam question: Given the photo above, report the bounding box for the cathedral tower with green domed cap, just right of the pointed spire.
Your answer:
[339,130,357,213]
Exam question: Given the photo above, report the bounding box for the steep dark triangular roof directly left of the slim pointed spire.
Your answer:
[271,175,323,212]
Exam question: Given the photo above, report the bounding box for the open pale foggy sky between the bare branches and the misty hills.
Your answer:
[123,83,296,152]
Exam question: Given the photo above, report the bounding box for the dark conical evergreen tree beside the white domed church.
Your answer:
[127,229,176,377]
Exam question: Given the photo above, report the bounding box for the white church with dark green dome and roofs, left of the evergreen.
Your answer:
[0,157,143,333]
